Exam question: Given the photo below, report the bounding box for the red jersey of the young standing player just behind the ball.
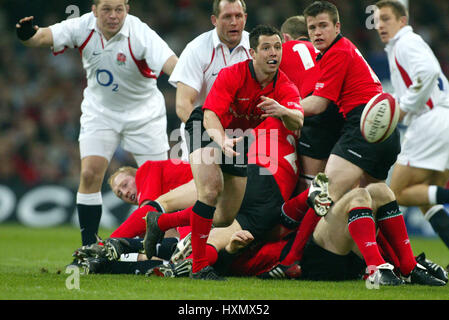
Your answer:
[313,35,382,115]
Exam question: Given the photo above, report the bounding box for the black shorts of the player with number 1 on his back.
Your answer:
[298,103,344,159]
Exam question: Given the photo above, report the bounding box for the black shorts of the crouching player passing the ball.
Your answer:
[185,107,248,177]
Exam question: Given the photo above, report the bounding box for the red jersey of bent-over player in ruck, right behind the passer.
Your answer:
[248,117,299,201]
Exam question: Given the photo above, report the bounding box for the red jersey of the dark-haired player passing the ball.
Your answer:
[203,59,302,131]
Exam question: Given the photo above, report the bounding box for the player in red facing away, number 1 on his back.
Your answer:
[279,16,343,198]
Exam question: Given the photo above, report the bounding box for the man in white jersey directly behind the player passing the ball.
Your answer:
[169,0,251,161]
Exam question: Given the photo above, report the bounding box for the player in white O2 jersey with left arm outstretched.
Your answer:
[16,0,178,245]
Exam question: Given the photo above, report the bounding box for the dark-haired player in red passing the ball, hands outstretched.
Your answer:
[144,26,303,279]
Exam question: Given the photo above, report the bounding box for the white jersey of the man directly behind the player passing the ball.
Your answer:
[168,28,251,106]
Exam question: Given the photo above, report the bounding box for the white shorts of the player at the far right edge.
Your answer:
[397,107,449,171]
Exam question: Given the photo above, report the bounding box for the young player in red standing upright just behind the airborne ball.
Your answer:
[287,1,400,268]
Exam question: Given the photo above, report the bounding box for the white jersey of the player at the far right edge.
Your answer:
[385,26,449,124]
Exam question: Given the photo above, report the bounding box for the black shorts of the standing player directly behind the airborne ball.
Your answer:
[331,106,401,180]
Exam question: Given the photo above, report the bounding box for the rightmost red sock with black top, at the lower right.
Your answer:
[377,201,416,276]
